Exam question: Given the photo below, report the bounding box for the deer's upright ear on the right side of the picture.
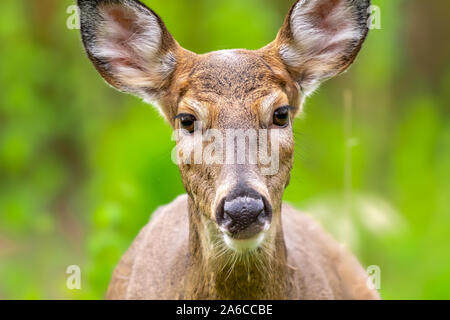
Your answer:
[274,0,370,95]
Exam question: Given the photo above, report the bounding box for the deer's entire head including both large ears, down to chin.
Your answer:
[78,0,370,250]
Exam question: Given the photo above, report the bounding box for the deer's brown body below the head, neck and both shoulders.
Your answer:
[107,195,379,299]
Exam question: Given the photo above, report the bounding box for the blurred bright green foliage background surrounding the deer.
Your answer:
[0,0,450,299]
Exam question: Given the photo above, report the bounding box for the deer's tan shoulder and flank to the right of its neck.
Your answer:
[282,204,380,300]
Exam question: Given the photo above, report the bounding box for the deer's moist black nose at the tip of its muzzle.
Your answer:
[216,190,272,239]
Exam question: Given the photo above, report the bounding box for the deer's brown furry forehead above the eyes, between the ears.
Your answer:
[178,50,296,121]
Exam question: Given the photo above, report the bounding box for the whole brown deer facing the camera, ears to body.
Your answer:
[78,0,379,299]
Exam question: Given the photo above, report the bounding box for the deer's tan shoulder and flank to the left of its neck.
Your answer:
[106,195,189,300]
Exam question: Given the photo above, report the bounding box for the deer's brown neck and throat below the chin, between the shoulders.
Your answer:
[186,195,290,300]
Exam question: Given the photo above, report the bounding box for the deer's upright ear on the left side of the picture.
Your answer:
[78,0,179,101]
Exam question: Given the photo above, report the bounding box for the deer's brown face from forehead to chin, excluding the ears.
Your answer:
[174,50,300,250]
